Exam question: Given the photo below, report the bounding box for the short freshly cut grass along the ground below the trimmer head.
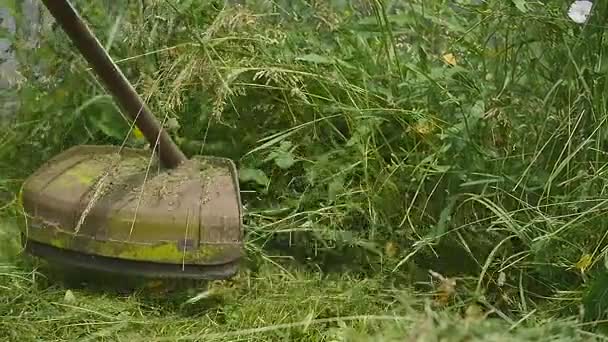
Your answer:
[0,238,599,341]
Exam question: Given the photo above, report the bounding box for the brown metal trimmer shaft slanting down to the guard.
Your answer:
[42,0,186,168]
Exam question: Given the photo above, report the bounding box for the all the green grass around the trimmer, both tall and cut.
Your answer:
[0,0,608,341]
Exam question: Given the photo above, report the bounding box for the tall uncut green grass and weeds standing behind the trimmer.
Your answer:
[0,0,608,340]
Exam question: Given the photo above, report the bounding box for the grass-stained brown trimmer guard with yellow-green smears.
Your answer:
[21,146,242,280]
